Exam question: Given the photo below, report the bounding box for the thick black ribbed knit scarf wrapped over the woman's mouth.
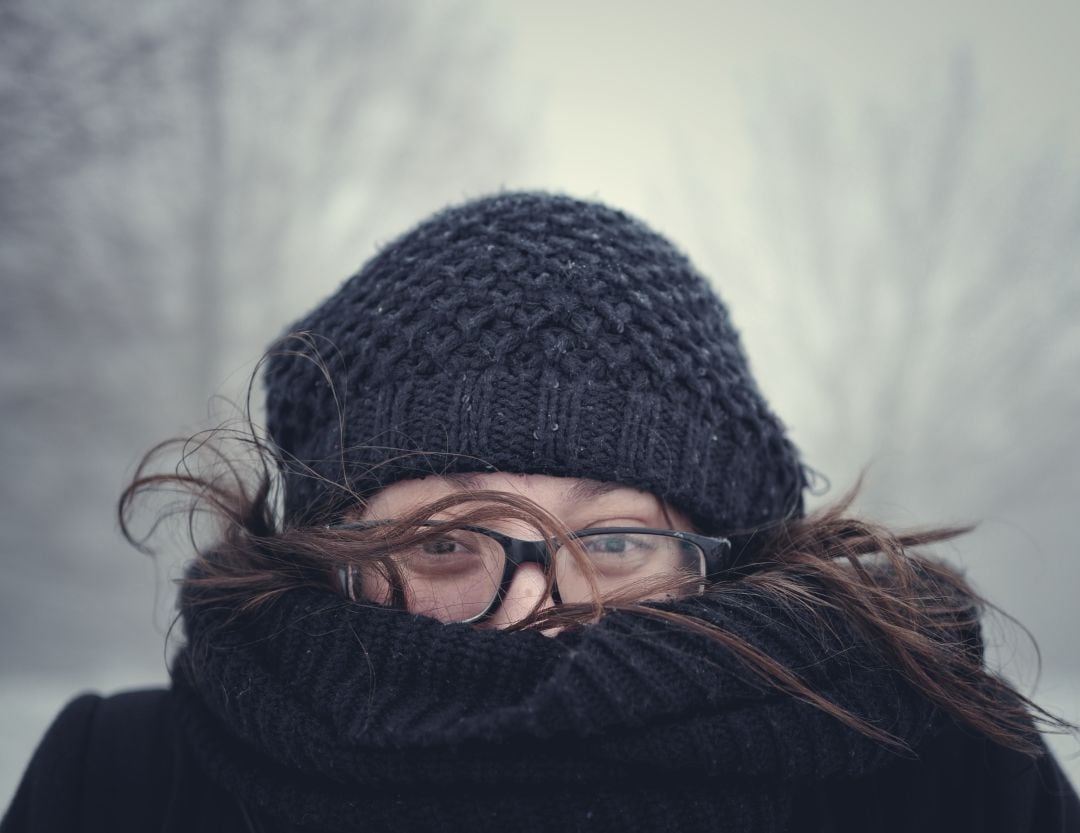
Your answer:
[174,589,936,832]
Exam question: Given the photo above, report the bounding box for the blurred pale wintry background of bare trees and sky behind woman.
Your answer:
[0,0,1080,807]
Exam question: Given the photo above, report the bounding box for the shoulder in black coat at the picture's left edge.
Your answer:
[2,689,203,833]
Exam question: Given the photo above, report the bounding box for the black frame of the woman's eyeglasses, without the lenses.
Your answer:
[327,521,731,624]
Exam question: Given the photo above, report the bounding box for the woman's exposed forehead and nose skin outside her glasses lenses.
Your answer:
[361,472,692,628]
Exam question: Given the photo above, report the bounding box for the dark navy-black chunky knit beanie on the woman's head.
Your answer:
[266,193,805,533]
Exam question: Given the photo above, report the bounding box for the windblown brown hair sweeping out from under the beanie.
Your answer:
[119,410,1076,753]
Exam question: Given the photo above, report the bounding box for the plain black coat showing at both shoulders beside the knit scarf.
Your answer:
[0,690,1080,833]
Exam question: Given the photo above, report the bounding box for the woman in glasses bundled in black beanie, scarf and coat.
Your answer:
[4,193,1080,833]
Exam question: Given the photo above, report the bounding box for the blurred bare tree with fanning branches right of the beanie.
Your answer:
[686,56,1080,691]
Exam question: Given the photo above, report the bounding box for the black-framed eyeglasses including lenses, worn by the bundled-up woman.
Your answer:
[332,521,731,622]
